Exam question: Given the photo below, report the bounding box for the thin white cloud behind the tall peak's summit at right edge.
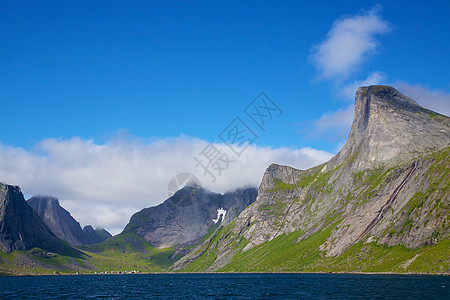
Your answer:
[396,82,450,116]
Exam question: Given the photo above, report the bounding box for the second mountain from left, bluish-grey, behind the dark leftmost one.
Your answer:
[27,196,111,246]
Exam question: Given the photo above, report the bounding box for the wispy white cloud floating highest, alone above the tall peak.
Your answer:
[310,6,390,80]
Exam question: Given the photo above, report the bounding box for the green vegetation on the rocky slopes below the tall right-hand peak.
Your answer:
[174,147,450,273]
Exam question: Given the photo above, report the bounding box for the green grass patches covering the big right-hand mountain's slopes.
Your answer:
[177,147,450,273]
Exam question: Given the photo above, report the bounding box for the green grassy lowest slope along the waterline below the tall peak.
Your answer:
[183,220,450,273]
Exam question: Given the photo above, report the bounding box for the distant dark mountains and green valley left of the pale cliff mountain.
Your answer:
[0,180,257,274]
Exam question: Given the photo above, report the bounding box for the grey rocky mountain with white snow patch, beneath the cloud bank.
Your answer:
[123,186,257,248]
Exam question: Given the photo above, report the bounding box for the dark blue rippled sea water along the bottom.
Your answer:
[0,274,450,299]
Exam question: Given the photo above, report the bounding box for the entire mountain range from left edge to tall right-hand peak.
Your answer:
[0,86,450,273]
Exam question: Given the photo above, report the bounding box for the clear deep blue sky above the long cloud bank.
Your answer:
[0,1,450,151]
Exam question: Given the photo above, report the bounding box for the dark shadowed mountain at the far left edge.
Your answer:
[0,183,81,256]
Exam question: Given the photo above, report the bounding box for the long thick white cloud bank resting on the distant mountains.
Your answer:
[0,137,332,233]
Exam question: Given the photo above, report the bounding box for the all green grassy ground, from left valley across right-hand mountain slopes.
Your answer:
[0,147,450,275]
